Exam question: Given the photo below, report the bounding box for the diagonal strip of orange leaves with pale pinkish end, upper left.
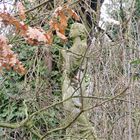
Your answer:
[0,13,50,45]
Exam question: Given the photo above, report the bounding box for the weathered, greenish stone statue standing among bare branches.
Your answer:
[62,23,97,140]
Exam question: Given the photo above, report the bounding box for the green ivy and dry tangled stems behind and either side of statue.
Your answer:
[0,0,140,140]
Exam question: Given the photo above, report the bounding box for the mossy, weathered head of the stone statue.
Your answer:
[70,23,87,38]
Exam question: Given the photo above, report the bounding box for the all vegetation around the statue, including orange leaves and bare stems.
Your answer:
[0,0,140,140]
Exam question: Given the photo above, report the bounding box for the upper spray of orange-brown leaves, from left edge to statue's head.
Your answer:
[0,2,79,45]
